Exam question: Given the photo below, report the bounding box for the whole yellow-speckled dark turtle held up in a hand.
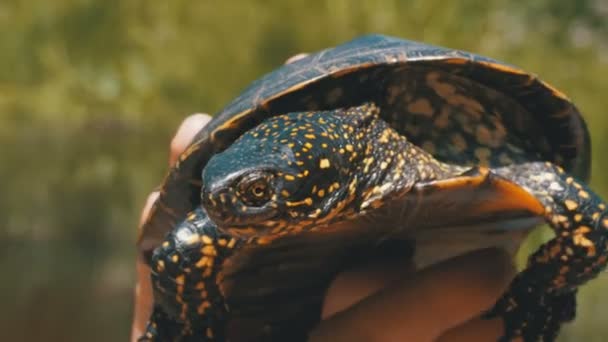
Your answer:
[138,35,608,341]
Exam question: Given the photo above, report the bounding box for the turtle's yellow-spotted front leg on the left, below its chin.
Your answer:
[139,208,243,341]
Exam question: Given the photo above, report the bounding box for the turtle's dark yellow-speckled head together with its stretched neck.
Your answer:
[201,104,464,236]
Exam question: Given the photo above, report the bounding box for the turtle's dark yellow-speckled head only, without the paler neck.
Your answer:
[201,105,377,231]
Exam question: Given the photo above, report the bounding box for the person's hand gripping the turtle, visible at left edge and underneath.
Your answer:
[131,55,515,342]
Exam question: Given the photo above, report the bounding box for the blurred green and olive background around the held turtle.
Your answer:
[0,0,608,341]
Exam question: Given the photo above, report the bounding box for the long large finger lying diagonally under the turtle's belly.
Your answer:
[311,250,514,341]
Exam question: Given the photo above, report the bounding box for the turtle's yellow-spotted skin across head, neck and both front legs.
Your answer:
[143,104,608,341]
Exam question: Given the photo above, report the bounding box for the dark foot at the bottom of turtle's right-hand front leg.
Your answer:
[486,280,576,342]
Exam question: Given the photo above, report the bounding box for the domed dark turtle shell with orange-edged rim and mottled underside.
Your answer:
[139,35,590,255]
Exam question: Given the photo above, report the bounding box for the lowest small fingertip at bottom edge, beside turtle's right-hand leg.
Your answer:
[435,317,520,342]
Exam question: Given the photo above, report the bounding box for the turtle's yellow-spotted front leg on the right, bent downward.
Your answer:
[488,162,608,342]
